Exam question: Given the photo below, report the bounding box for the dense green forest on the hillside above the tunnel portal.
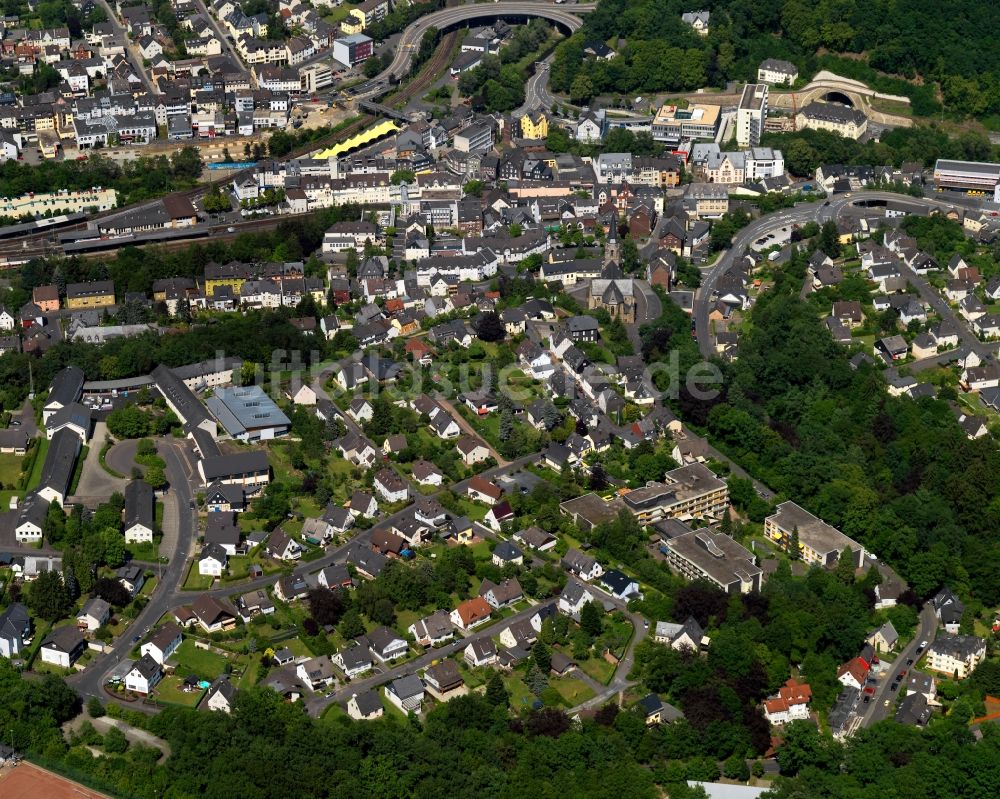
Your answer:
[551,0,1000,121]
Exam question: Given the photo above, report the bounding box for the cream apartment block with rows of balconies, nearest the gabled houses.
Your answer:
[622,463,729,524]
